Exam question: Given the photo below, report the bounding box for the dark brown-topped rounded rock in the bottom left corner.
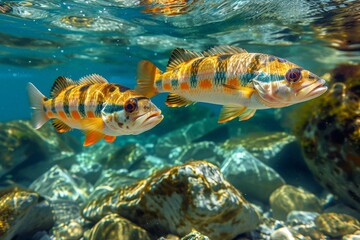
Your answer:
[0,189,53,240]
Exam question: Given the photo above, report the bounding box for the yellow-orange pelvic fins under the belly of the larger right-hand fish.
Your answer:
[218,105,256,123]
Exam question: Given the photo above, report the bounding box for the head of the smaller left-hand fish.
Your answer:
[102,95,164,135]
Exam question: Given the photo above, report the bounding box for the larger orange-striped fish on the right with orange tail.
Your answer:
[135,46,327,122]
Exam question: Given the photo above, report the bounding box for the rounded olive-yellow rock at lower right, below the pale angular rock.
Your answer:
[270,185,321,220]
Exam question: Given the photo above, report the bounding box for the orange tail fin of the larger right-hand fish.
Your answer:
[135,60,161,98]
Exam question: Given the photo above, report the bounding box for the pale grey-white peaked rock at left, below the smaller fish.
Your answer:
[29,165,91,203]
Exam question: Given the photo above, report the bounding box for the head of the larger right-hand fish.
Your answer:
[253,56,328,108]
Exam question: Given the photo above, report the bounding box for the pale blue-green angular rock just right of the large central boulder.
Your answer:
[221,147,285,202]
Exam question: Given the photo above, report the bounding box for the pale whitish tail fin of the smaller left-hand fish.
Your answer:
[27,82,49,129]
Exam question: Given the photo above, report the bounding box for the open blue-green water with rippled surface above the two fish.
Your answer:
[0,0,359,121]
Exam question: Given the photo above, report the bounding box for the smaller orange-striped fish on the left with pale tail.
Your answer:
[28,74,163,146]
